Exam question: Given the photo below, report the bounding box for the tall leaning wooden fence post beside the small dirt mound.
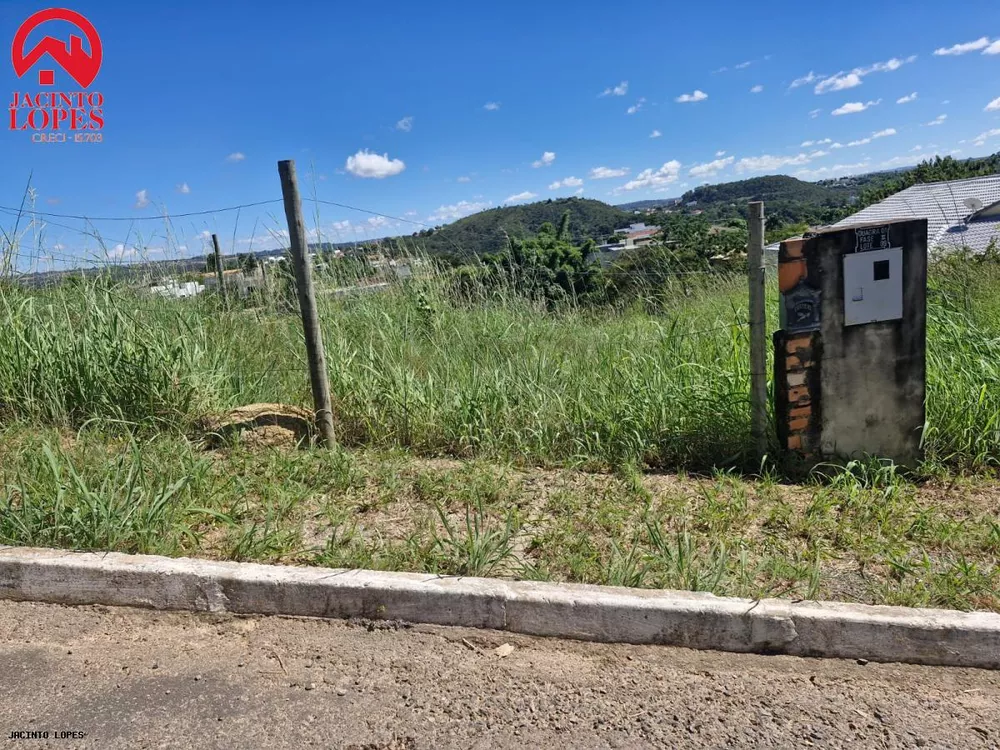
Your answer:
[278,161,334,445]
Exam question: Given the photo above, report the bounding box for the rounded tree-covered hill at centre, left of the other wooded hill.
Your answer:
[409,198,634,257]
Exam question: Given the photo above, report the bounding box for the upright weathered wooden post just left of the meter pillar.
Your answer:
[747,201,768,461]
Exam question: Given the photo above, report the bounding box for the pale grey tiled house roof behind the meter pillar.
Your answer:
[834,175,1000,250]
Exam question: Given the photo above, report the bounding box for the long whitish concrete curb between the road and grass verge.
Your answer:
[0,547,1000,669]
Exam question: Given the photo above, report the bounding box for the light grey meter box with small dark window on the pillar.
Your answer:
[844,247,903,326]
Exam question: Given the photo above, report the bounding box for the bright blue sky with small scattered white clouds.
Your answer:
[0,0,1000,268]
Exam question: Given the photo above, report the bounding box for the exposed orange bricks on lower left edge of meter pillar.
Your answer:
[774,331,821,458]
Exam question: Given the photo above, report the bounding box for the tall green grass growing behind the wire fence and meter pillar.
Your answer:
[0,259,1000,469]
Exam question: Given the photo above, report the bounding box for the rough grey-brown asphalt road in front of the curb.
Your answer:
[0,602,1000,750]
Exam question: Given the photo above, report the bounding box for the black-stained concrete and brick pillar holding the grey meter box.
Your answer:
[774,219,927,466]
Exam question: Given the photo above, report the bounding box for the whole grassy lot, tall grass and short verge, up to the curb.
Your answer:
[0,260,1000,611]
